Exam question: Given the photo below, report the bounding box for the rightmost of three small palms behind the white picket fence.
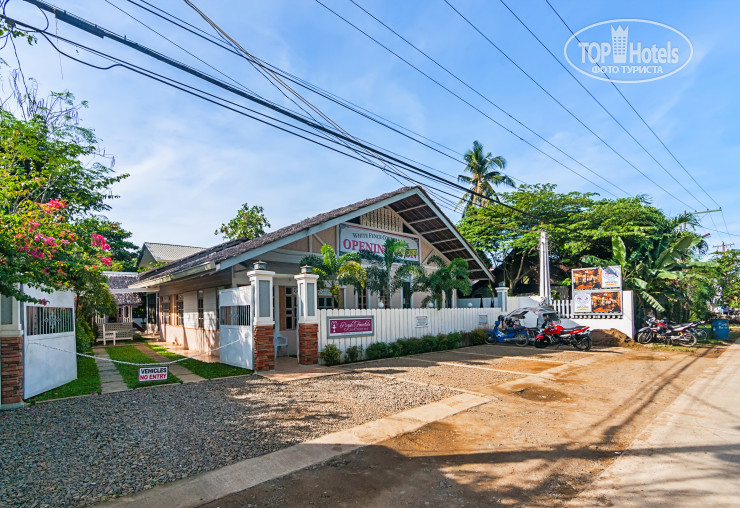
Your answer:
[414,255,473,310]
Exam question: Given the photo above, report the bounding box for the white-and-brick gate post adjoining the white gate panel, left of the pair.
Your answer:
[247,261,275,372]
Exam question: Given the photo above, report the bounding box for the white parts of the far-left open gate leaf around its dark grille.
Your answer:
[23,288,77,399]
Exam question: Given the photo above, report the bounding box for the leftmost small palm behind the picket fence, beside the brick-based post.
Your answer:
[300,245,367,307]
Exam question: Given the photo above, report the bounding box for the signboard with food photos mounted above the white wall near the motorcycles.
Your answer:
[571,265,622,314]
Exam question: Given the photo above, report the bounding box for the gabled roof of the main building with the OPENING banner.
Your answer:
[136,187,492,287]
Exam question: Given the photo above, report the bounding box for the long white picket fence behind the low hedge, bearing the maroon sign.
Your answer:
[319,307,501,360]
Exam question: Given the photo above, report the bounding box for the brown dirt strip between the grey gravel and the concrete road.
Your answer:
[202,345,721,507]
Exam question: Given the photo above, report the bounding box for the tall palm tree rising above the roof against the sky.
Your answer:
[457,141,516,215]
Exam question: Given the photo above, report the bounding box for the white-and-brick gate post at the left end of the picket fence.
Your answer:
[295,266,319,365]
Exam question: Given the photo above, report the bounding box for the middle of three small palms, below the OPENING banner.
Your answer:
[360,238,423,308]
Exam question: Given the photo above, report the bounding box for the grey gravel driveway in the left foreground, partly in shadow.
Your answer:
[0,373,454,507]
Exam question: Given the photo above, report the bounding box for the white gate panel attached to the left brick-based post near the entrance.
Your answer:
[218,286,254,370]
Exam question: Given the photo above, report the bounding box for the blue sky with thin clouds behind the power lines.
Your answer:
[0,0,740,251]
